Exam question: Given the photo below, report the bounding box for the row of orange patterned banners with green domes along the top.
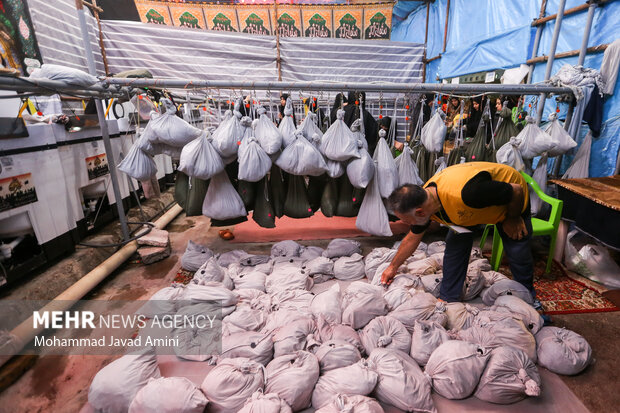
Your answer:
[133,0,394,40]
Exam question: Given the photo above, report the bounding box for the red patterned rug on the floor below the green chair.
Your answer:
[499,253,620,314]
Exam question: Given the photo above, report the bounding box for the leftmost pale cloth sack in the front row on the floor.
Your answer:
[88,348,161,413]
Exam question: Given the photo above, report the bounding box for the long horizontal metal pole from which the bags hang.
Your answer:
[103,78,572,95]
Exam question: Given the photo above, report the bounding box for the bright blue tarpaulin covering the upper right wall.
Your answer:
[392,0,620,177]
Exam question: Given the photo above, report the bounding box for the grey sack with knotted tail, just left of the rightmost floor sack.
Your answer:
[474,346,541,404]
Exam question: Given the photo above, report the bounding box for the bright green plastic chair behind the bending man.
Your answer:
[480,172,564,273]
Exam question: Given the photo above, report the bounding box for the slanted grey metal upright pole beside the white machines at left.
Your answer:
[75,0,129,241]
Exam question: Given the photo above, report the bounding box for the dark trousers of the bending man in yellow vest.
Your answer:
[439,214,535,302]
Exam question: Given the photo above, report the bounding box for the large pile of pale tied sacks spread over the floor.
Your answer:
[89,243,592,413]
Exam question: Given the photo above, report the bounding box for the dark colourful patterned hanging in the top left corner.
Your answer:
[0,0,41,74]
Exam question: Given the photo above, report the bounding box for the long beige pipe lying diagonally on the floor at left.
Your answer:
[0,204,183,366]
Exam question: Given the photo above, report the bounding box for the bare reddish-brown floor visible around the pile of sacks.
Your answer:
[0,206,620,413]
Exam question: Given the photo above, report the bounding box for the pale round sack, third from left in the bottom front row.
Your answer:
[200,358,265,413]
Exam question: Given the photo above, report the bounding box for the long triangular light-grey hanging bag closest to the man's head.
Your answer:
[355,169,392,237]
